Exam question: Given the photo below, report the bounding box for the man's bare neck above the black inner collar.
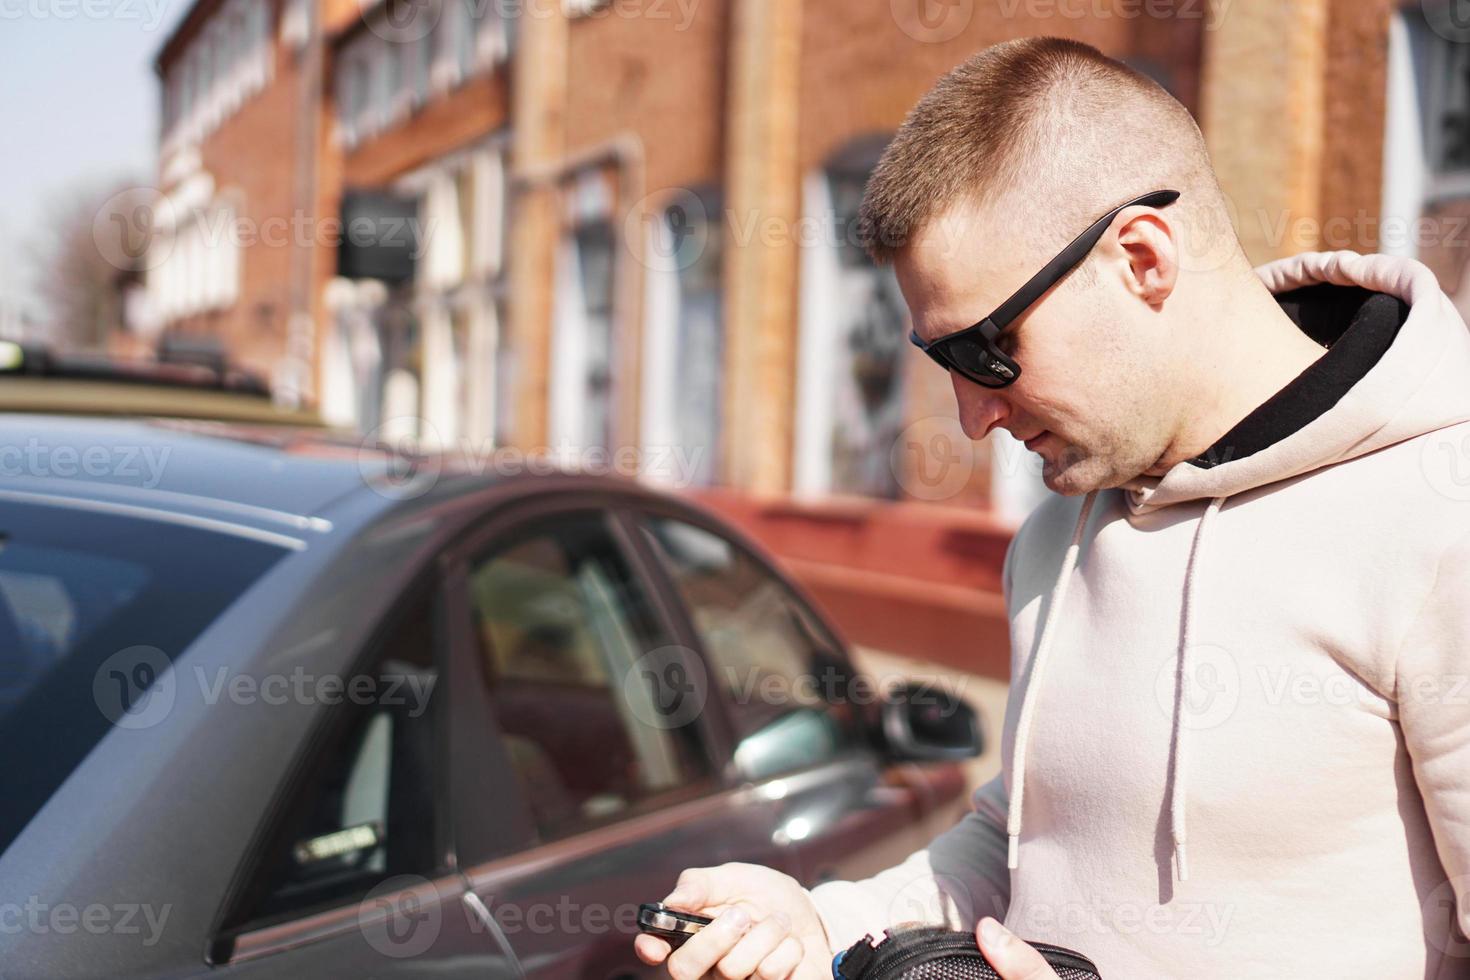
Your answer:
[1145,282,1327,476]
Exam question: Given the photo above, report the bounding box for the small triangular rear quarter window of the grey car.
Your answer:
[237,595,444,923]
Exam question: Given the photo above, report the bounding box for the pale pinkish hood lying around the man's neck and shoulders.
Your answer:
[1126,251,1470,514]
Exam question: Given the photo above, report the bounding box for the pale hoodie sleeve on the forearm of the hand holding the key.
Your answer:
[810,776,1010,952]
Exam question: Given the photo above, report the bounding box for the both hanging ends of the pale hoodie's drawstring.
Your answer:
[1005,491,1226,882]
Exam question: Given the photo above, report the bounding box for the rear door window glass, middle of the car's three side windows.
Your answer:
[469,511,710,840]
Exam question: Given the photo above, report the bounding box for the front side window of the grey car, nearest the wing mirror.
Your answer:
[642,516,860,779]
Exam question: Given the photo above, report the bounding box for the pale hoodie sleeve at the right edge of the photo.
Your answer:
[1395,535,1470,952]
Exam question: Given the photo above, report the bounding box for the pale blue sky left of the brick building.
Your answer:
[0,0,188,318]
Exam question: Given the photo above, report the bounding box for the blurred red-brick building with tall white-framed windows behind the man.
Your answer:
[138,0,1470,671]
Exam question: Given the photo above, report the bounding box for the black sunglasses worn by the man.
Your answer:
[908,191,1179,388]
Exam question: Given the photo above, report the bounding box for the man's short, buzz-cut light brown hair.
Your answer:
[858,37,1239,264]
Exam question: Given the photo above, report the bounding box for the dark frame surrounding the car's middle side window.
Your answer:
[447,491,729,867]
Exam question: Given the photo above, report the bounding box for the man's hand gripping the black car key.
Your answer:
[634,864,832,980]
